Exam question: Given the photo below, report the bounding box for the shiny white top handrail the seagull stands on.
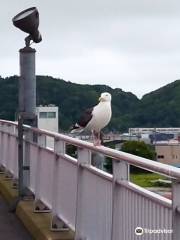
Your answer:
[0,120,180,179]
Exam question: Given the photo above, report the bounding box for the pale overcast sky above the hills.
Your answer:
[0,0,180,97]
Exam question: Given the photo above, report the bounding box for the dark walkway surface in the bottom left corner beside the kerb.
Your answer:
[0,195,32,240]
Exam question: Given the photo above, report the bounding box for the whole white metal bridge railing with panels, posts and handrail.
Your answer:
[0,120,180,240]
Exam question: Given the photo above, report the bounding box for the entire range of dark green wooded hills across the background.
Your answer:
[0,76,180,131]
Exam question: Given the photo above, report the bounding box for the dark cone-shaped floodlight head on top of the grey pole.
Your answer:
[12,7,42,43]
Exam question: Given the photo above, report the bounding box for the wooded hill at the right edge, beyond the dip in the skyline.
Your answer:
[133,80,180,127]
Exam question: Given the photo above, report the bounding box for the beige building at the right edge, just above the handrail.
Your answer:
[155,140,180,167]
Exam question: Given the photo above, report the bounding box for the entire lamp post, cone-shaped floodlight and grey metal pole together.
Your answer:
[12,7,42,198]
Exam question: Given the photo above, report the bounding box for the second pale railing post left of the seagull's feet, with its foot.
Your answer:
[51,138,69,231]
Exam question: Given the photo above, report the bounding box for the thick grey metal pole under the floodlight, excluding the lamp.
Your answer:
[18,46,37,197]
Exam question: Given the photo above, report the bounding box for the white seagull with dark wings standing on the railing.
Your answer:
[71,92,112,146]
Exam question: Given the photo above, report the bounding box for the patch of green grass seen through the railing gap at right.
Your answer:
[130,173,167,187]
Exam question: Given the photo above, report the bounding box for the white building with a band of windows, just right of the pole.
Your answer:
[37,104,59,148]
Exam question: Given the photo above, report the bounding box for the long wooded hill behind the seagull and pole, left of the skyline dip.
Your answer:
[0,76,139,130]
